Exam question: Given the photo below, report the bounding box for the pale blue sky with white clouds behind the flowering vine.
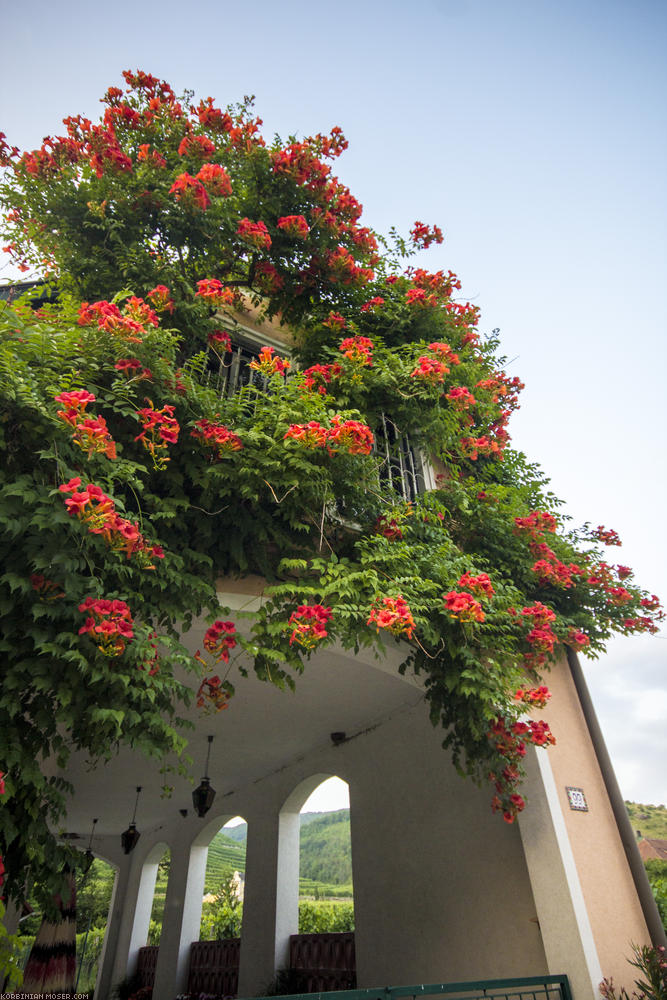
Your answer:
[0,0,667,808]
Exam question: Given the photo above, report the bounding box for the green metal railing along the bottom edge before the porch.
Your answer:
[245,976,572,1000]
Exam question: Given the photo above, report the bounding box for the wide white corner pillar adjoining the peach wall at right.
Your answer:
[519,747,602,1000]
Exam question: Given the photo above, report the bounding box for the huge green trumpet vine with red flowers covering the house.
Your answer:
[0,73,660,907]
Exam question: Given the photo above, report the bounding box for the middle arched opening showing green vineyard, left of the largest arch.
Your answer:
[199,816,248,941]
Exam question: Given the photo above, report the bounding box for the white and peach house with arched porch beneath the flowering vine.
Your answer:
[3,302,660,1000]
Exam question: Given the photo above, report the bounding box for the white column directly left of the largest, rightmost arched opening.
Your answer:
[239,805,299,996]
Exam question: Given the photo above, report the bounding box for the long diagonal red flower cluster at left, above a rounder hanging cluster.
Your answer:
[58,476,164,569]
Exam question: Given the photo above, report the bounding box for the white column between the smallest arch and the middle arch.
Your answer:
[153,838,208,1000]
